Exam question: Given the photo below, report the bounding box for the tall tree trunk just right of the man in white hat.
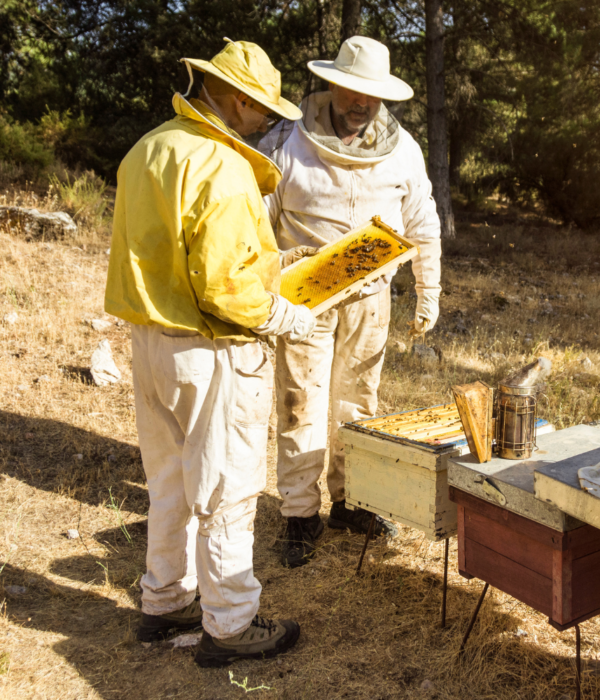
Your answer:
[425,0,456,238]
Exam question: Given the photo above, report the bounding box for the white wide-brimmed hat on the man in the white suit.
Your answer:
[308,36,414,102]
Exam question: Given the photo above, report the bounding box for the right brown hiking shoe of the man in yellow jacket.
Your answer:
[196,615,300,668]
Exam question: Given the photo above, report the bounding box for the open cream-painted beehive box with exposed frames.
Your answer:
[339,404,468,542]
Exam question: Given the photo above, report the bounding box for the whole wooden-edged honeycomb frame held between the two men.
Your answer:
[280,216,419,316]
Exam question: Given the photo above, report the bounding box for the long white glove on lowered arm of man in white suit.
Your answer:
[410,238,442,338]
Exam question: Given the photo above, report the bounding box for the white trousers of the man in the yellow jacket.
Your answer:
[131,325,273,639]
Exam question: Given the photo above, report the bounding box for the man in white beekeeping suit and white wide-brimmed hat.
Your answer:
[260,36,441,567]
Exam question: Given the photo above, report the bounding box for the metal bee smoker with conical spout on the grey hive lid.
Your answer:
[495,357,552,459]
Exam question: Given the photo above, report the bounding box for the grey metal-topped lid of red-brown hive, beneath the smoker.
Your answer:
[448,425,600,532]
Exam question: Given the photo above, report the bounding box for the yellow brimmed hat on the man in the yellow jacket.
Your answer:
[181,37,302,119]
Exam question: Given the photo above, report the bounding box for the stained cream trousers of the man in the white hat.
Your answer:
[276,287,390,518]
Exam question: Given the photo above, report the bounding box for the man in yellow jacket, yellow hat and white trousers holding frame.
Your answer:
[105,40,314,666]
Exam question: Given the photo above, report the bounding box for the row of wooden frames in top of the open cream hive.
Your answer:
[354,403,465,445]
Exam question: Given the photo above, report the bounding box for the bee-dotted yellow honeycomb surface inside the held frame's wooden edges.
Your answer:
[281,225,406,309]
